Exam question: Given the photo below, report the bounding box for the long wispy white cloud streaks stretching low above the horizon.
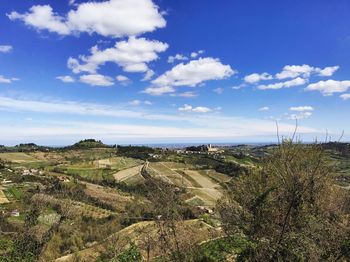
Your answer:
[0,97,324,143]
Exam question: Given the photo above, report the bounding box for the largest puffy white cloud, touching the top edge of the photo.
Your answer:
[7,0,166,37]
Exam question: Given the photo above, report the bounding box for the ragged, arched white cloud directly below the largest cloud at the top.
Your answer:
[67,37,168,78]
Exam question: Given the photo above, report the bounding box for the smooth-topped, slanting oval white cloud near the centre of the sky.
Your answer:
[152,57,235,87]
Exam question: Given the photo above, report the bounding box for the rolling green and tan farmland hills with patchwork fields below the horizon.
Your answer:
[0,139,350,261]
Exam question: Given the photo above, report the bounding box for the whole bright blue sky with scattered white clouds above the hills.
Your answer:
[0,0,350,145]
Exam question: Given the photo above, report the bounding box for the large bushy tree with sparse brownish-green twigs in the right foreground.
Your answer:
[218,140,350,261]
